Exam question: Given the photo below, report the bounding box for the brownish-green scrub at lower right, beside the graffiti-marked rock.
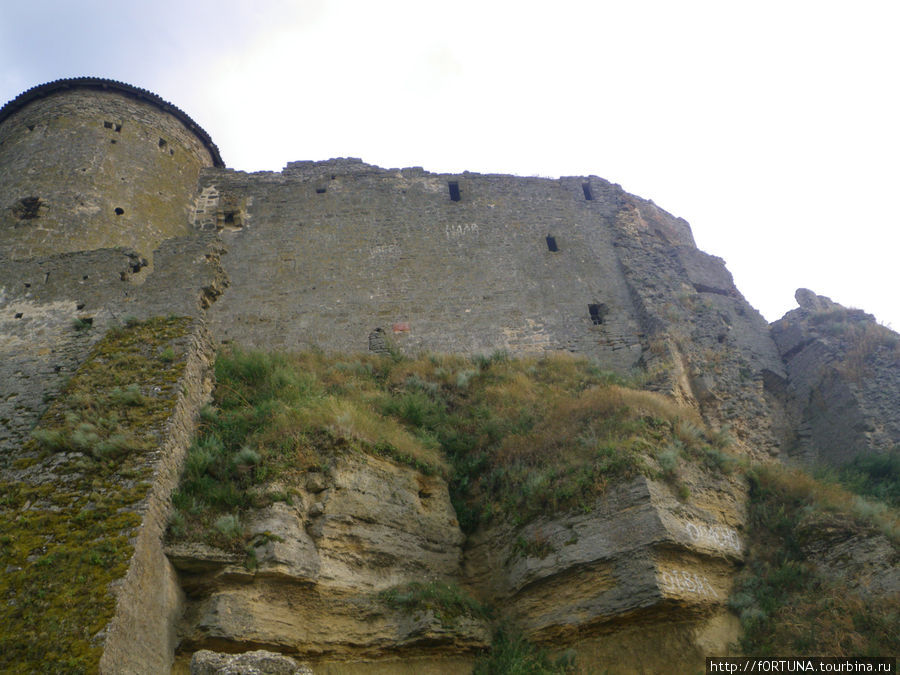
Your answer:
[730,457,900,656]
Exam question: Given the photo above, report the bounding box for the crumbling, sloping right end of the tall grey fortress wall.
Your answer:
[614,195,789,459]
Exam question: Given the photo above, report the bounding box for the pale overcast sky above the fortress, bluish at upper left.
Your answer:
[0,0,900,330]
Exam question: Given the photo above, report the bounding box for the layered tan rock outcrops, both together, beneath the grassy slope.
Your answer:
[168,448,745,672]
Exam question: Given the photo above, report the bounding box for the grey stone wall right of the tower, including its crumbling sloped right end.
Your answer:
[193,159,785,454]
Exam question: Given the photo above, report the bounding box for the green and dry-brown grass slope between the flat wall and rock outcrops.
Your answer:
[170,350,727,548]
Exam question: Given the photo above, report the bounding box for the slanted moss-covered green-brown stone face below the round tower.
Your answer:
[0,317,191,673]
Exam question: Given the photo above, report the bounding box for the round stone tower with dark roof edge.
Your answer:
[0,78,223,259]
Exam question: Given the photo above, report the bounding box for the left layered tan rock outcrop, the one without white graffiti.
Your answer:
[168,456,490,661]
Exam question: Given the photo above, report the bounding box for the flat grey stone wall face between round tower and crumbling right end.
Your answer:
[195,160,656,372]
